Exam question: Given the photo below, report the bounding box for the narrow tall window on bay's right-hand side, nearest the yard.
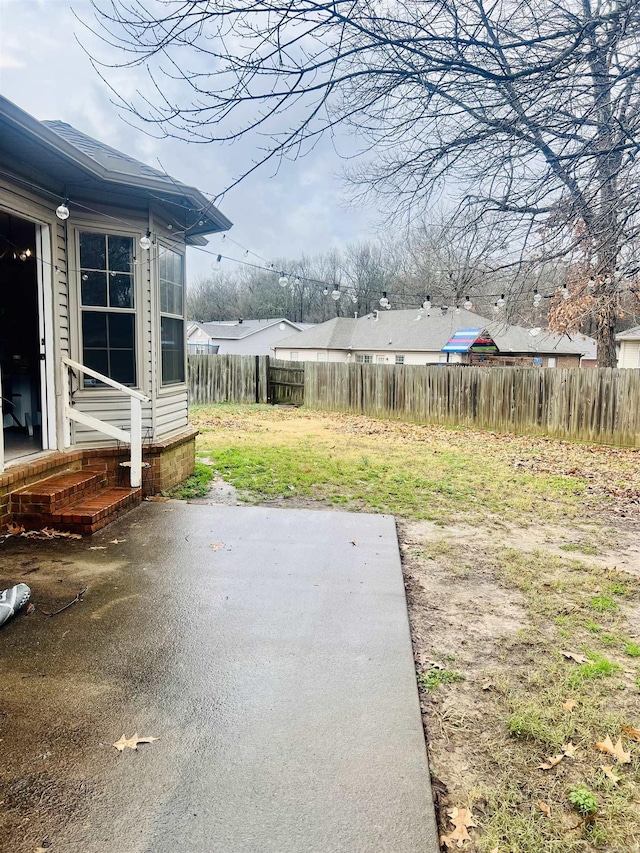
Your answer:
[159,248,185,385]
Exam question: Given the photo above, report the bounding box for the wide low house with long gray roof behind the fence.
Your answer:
[276,308,595,367]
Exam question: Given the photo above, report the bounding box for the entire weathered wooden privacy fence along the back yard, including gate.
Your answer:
[188,355,640,447]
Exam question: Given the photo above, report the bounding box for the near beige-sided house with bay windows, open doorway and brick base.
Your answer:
[0,97,231,527]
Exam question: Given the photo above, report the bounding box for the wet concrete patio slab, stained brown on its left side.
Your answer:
[0,501,438,853]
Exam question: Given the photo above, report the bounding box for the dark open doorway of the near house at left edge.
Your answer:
[0,212,42,462]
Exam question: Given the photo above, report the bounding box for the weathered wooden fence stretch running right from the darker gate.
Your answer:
[304,362,640,447]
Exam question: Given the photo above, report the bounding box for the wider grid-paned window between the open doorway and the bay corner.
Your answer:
[80,232,136,388]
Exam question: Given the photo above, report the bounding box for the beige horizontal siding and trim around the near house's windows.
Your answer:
[0,174,188,449]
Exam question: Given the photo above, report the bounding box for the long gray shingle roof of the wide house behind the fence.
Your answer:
[277,308,595,357]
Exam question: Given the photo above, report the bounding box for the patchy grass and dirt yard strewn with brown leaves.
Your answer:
[193,406,640,853]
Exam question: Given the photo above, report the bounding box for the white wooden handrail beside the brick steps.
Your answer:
[62,355,150,489]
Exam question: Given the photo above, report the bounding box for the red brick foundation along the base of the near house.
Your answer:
[0,427,198,525]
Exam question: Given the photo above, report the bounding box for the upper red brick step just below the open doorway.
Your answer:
[11,468,107,522]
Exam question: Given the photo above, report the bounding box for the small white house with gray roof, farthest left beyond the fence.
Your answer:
[187,317,309,355]
